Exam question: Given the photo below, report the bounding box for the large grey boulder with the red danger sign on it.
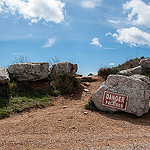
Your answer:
[91,75,150,116]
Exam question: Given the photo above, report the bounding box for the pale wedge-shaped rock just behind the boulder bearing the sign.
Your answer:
[119,66,142,76]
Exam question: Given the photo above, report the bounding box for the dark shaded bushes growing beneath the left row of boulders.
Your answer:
[9,73,79,98]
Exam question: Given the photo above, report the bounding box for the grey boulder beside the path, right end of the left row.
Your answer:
[49,62,78,79]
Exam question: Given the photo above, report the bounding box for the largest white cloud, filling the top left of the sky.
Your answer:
[0,0,65,23]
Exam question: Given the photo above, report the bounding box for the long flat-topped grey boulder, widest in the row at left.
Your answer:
[8,62,49,81]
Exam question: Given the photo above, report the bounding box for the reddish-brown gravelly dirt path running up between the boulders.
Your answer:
[0,77,150,150]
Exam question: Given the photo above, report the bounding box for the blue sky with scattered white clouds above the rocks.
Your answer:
[0,0,150,75]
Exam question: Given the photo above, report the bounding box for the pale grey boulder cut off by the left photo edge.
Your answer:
[0,67,10,84]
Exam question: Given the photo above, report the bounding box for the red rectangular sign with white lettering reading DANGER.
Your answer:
[103,91,127,110]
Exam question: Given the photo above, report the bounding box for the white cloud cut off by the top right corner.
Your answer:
[123,0,150,26]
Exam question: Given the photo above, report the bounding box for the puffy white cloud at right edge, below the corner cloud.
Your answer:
[113,27,150,47]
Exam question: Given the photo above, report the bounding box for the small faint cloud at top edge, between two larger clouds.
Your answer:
[80,0,102,8]
